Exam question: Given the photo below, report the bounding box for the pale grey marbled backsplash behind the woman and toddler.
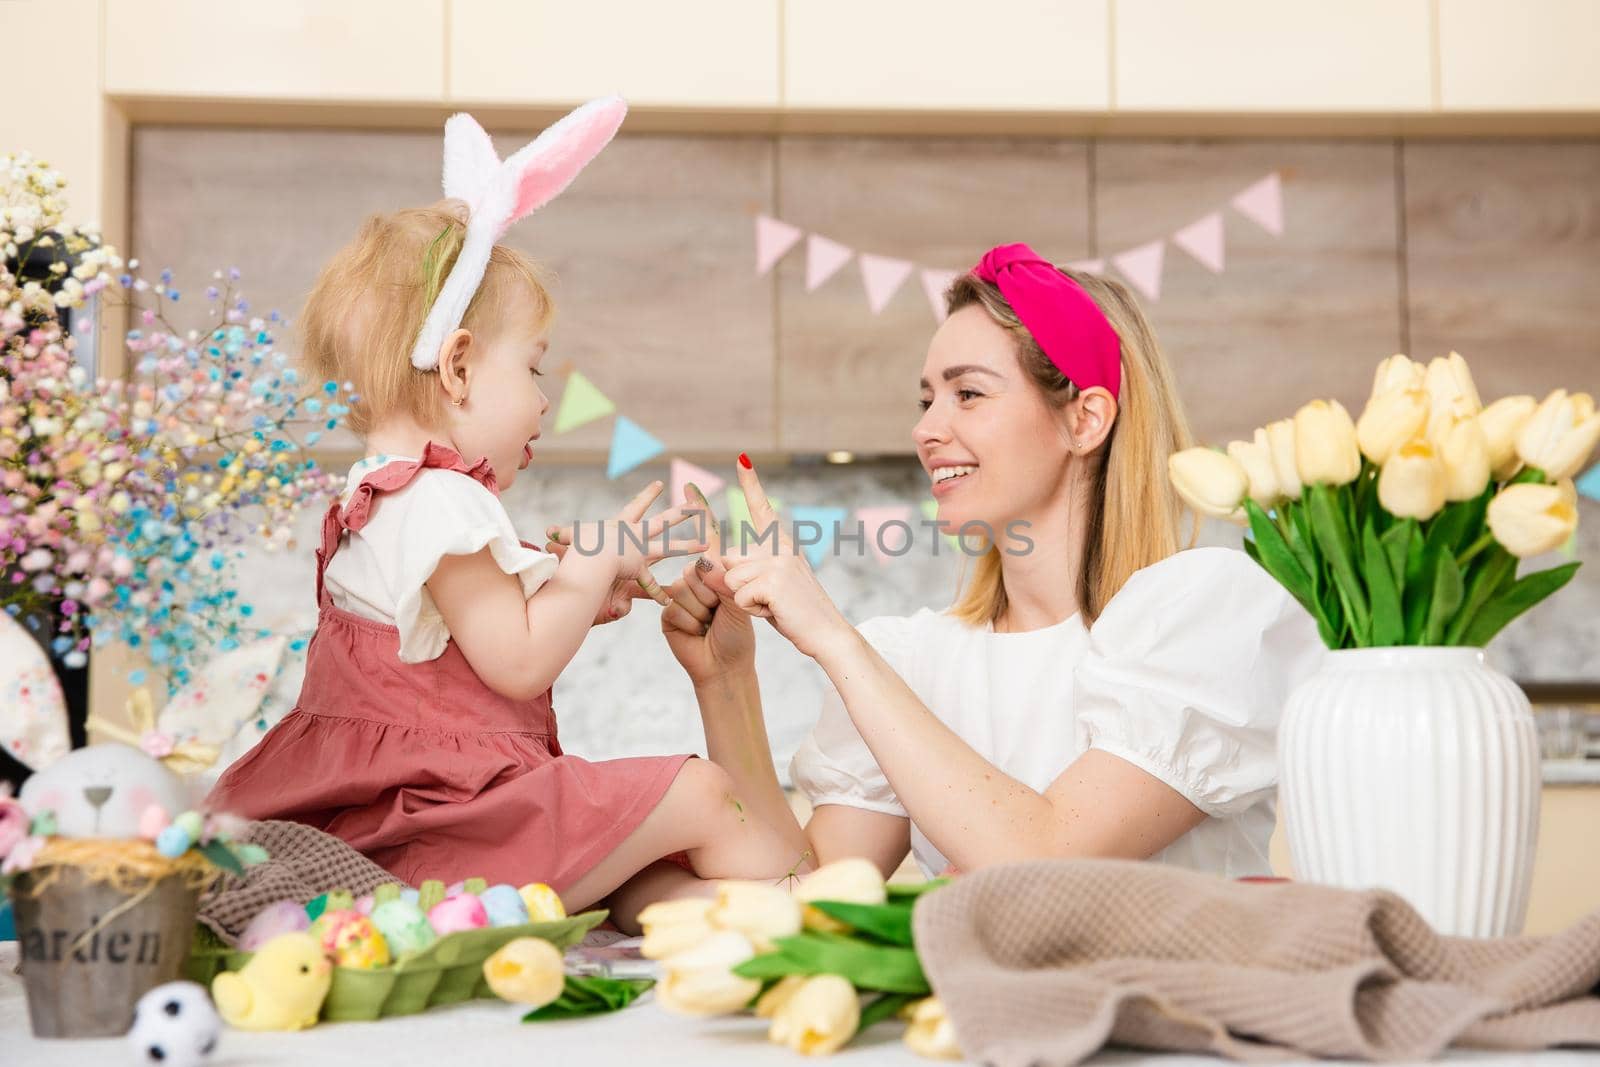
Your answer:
[242,461,1600,779]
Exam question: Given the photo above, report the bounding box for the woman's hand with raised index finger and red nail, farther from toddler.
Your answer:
[722,456,856,659]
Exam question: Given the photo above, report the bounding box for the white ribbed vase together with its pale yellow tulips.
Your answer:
[1170,352,1600,936]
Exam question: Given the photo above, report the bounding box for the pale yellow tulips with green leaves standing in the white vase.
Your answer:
[1168,352,1600,648]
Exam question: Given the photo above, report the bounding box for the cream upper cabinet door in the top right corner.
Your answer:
[1438,0,1600,110]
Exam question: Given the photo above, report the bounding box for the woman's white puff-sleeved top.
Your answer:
[789,549,1323,878]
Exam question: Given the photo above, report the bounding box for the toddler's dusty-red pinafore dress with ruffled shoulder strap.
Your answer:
[211,445,691,893]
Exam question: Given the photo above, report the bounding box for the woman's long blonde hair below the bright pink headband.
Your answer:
[946,267,1189,625]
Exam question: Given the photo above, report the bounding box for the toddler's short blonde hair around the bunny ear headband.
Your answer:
[301,200,555,437]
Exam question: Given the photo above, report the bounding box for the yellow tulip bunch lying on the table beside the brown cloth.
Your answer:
[638,859,960,1059]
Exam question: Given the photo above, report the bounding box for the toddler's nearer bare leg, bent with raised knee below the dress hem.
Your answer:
[562,760,813,912]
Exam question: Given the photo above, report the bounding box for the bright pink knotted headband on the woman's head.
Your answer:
[973,245,1122,398]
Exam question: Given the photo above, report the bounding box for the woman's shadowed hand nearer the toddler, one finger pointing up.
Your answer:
[661,483,755,685]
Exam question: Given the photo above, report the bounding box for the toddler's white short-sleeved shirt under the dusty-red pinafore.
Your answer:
[323,456,558,664]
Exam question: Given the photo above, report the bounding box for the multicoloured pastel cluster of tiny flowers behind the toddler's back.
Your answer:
[0,154,354,700]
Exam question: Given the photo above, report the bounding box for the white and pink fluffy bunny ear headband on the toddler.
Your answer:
[411,96,627,371]
